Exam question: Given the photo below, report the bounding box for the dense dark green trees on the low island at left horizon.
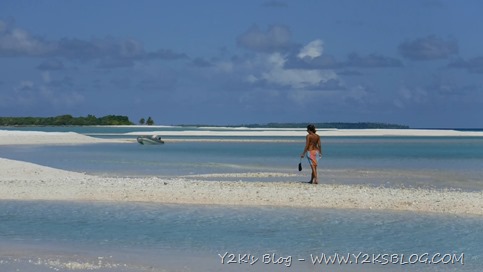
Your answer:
[0,114,133,126]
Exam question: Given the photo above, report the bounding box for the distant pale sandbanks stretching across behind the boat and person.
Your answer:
[0,128,483,145]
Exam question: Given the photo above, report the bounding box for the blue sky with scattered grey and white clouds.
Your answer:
[0,0,483,128]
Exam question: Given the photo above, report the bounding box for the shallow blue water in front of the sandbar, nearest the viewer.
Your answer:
[0,201,483,271]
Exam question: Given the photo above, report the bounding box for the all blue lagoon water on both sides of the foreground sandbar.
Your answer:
[0,127,483,272]
